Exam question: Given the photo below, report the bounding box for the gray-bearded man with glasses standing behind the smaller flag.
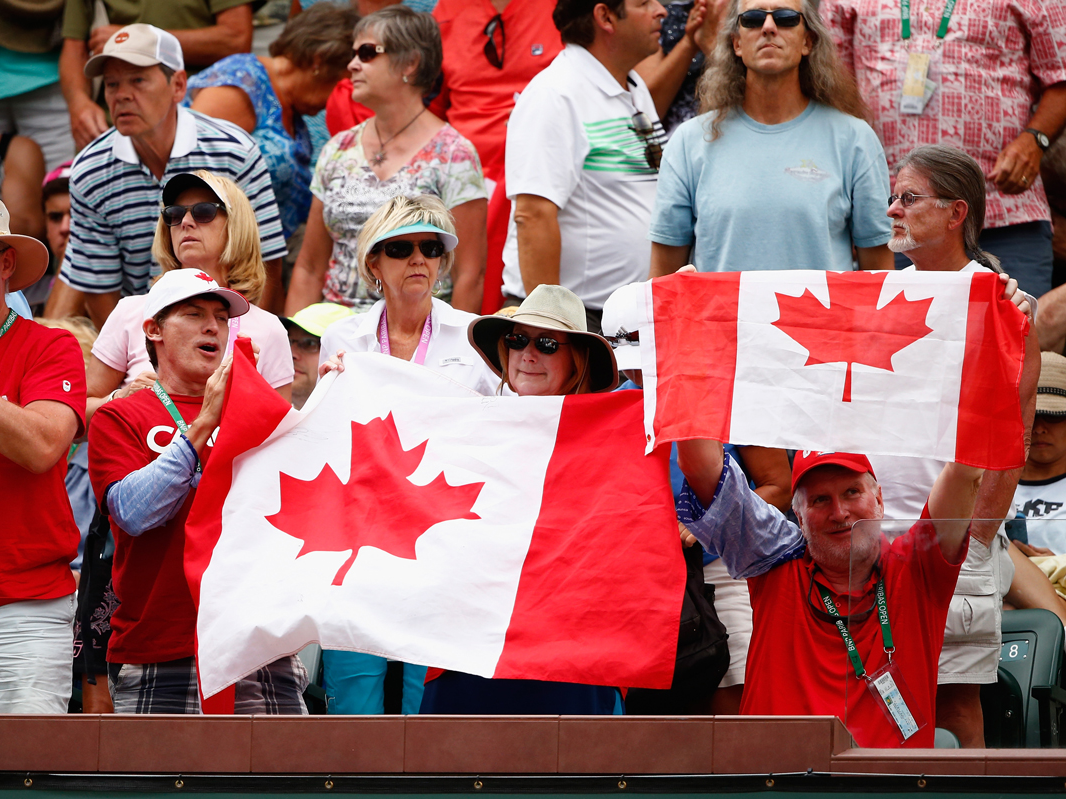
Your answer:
[870,145,1057,747]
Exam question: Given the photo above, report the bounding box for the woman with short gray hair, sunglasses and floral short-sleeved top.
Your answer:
[286,5,488,316]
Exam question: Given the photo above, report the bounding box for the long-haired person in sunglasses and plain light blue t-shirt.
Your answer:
[649,0,892,277]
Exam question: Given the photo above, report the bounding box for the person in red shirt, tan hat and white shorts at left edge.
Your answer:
[0,202,85,714]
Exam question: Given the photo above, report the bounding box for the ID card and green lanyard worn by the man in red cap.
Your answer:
[817,577,925,744]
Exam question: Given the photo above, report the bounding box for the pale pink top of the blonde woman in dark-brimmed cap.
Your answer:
[93,294,293,389]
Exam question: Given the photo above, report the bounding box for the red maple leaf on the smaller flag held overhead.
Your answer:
[774,272,933,403]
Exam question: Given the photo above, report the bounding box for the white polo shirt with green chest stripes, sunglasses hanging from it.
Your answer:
[503,45,659,310]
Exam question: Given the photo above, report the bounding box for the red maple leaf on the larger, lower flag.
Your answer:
[267,413,485,585]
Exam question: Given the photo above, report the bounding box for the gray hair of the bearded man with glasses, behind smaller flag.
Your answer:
[897,144,1003,272]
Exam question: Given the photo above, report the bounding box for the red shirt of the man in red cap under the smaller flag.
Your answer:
[741,522,966,748]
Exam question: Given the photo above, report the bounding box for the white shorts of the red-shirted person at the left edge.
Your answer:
[0,593,77,714]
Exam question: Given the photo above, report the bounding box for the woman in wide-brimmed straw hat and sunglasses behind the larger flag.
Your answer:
[411,284,623,715]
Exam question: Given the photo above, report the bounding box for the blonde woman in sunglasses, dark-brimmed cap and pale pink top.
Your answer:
[85,169,293,428]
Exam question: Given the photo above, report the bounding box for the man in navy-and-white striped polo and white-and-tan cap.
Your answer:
[51,23,286,327]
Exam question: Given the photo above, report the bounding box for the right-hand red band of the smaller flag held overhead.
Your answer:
[955,273,1029,469]
